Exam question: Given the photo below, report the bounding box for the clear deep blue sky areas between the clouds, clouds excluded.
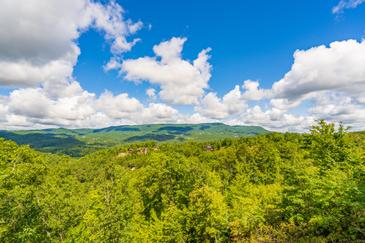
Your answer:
[75,0,365,99]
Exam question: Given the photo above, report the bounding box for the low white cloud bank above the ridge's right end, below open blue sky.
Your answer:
[192,81,315,132]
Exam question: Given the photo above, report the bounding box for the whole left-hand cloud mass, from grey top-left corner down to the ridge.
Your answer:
[0,0,186,129]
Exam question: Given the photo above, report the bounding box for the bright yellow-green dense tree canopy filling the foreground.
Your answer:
[0,122,365,242]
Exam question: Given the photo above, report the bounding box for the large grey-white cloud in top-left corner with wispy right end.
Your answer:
[0,0,142,87]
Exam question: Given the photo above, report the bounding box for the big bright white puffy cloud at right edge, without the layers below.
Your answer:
[272,40,365,102]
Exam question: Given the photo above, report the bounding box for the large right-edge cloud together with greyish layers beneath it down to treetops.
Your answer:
[262,40,365,129]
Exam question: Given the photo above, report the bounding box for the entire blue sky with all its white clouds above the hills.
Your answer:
[0,0,365,131]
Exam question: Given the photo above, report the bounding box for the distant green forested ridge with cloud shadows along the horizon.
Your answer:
[0,123,268,156]
